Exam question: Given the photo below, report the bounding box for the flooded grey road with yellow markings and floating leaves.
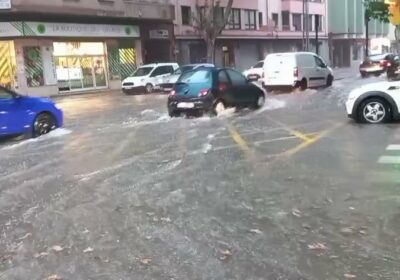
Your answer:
[0,70,400,280]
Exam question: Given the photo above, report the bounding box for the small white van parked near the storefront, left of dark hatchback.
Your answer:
[122,63,179,94]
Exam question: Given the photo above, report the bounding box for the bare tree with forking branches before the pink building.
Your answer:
[192,0,233,63]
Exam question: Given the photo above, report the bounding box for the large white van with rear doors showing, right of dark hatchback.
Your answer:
[264,52,334,91]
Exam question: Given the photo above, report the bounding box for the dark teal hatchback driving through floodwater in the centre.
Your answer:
[168,68,265,117]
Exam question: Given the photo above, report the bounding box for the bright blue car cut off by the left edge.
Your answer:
[0,86,63,137]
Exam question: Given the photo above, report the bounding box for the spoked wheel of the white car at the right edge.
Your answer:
[358,98,390,124]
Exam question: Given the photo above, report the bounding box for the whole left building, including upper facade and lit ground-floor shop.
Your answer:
[0,0,174,96]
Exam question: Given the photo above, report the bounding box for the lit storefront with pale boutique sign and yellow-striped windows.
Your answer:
[0,22,142,96]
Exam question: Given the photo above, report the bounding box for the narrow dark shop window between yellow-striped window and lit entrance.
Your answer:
[23,47,44,87]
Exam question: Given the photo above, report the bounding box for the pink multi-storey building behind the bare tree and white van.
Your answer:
[170,0,329,69]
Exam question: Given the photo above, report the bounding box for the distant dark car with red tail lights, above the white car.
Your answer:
[360,53,395,78]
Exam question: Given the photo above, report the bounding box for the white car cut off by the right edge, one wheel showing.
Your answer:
[346,81,400,124]
